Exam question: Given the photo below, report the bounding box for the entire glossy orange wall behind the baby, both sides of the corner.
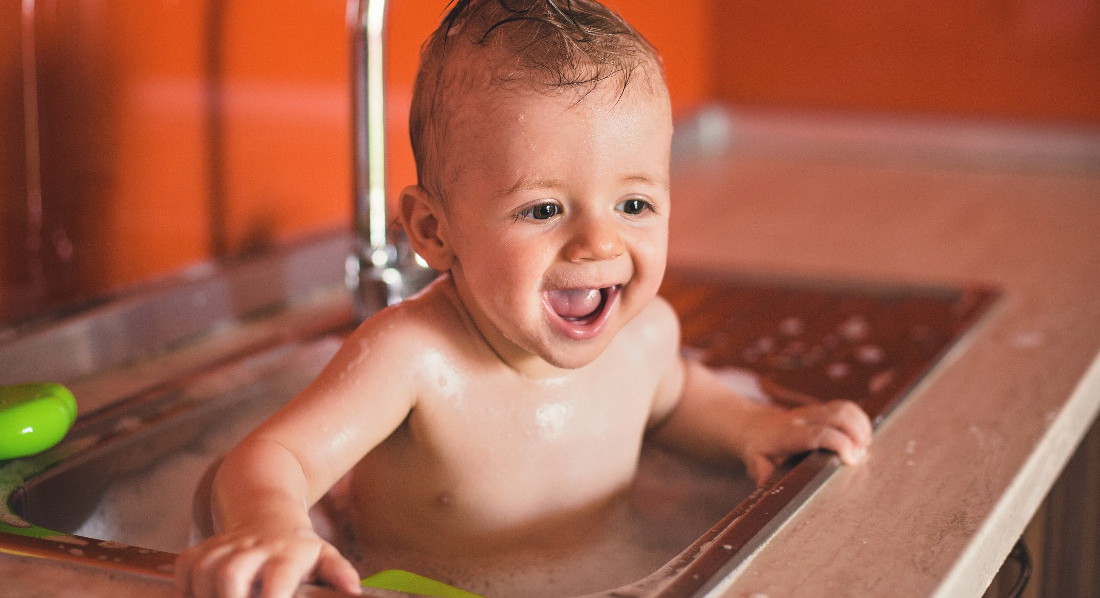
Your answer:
[0,0,1100,323]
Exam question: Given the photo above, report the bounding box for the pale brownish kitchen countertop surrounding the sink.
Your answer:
[0,111,1100,598]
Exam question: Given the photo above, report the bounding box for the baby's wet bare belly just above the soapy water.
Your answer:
[348,439,636,557]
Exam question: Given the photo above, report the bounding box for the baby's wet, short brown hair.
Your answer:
[409,0,664,200]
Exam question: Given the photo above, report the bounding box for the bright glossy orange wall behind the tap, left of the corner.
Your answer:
[0,0,706,322]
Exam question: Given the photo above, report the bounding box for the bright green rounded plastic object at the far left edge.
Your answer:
[0,383,76,459]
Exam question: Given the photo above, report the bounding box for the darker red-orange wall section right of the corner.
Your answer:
[708,0,1100,125]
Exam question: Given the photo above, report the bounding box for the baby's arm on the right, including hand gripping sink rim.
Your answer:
[650,327,871,485]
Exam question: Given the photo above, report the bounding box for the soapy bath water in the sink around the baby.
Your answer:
[18,336,754,596]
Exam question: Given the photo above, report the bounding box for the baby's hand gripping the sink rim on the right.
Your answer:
[741,400,871,486]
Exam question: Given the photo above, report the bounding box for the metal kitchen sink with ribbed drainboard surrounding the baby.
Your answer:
[0,236,996,597]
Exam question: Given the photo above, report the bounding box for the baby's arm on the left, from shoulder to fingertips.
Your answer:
[176,314,415,597]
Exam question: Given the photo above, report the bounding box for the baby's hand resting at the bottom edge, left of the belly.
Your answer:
[176,528,362,598]
